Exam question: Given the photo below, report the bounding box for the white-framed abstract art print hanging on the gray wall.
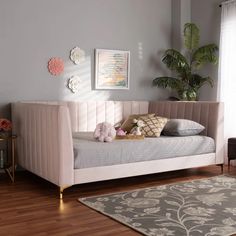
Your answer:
[95,49,130,89]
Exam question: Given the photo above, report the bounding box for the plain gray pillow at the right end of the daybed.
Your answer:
[162,119,205,136]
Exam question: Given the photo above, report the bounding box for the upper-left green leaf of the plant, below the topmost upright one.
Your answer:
[162,49,191,77]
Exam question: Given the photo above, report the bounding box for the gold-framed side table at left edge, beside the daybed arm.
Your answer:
[0,135,17,182]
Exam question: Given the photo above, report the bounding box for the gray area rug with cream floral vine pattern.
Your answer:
[79,175,236,236]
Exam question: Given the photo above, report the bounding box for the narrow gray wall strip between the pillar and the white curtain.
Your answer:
[191,0,222,100]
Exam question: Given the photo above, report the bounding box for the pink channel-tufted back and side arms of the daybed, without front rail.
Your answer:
[12,101,224,187]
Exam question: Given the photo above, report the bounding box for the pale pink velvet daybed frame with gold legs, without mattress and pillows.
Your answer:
[12,101,224,197]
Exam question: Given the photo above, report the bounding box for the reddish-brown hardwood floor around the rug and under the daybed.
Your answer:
[0,166,236,236]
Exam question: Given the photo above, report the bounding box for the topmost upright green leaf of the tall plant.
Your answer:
[184,23,200,51]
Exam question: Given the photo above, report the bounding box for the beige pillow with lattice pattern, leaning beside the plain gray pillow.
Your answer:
[141,116,168,137]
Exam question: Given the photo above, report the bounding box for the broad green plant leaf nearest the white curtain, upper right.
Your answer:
[191,43,218,68]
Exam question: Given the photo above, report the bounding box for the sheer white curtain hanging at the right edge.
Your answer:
[218,0,236,164]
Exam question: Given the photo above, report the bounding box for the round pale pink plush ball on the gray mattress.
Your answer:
[93,122,116,142]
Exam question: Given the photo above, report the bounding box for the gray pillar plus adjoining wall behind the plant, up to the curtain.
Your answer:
[172,0,222,100]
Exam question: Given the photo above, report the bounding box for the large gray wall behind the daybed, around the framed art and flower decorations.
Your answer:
[0,0,172,116]
